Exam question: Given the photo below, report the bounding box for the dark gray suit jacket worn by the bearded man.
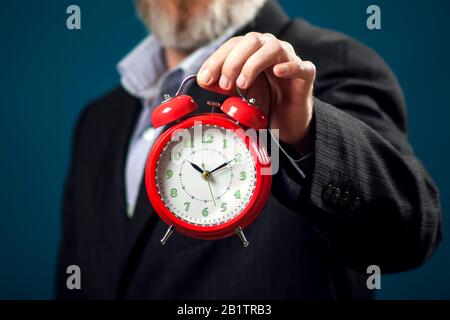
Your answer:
[57,1,441,299]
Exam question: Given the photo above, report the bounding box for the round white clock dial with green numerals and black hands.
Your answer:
[156,125,256,226]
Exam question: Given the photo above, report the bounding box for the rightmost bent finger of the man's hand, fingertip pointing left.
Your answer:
[273,58,316,83]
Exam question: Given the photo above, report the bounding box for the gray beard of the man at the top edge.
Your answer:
[139,0,266,51]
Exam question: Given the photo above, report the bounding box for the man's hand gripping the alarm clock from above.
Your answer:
[197,32,316,154]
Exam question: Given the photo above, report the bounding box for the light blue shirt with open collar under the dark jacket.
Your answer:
[117,28,236,218]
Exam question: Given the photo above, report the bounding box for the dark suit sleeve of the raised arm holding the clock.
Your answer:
[273,35,441,273]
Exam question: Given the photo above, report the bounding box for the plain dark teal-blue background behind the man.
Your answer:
[0,0,450,299]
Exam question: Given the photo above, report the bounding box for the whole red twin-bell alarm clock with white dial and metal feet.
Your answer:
[145,75,272,247]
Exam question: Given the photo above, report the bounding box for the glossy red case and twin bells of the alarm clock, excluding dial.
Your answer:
[145,79,272,240]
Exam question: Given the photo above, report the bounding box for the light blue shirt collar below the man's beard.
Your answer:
[117,27,237,101]
